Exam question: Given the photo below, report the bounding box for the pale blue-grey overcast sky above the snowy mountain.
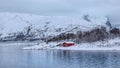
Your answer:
[0,0,120,22]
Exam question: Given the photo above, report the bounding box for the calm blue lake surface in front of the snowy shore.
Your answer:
[0,44,120,68]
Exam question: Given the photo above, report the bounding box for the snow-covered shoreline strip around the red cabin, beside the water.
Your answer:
[23,38,120,50]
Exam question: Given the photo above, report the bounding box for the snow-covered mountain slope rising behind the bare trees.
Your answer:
[0,13,107,37]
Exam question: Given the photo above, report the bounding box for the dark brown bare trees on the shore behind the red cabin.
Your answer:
[46,27,120,43]
